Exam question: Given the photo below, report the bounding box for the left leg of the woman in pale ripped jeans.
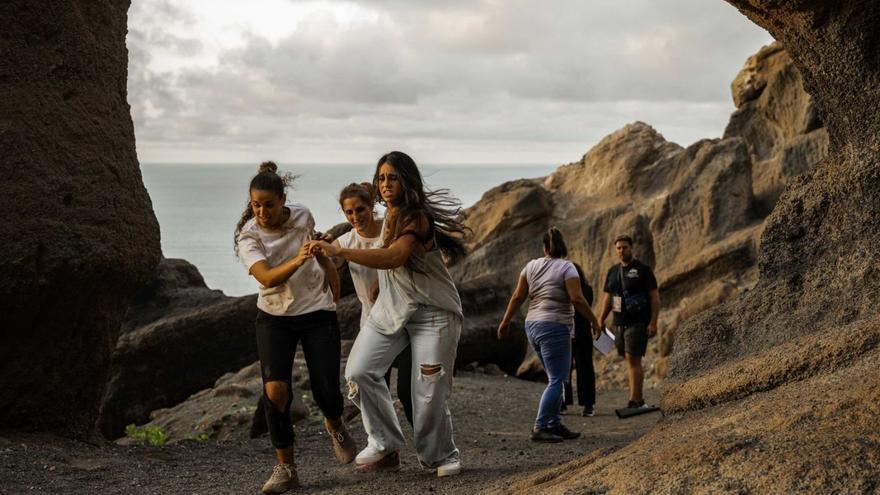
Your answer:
[345,322,407,462]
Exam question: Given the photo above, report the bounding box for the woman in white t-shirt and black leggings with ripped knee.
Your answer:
[235,162,357,493]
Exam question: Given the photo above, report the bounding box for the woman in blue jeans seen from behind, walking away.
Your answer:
[498,227,600,443]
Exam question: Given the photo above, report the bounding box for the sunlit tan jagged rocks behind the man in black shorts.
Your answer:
[453,44,827,384]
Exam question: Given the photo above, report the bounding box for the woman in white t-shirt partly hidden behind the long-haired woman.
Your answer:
[333,182,413,425]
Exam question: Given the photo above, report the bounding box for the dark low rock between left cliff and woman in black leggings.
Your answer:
[98,259,257,438]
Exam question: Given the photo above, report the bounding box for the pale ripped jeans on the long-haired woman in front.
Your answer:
[345,306,462,468]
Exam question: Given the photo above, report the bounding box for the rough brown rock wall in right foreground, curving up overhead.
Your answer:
[488,0,880,493]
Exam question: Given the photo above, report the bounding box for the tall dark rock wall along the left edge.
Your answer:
[0,0,160,436]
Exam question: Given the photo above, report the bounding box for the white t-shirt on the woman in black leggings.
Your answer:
[238,203,336,316]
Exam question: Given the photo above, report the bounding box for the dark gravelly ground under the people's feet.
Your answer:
[0,373,660,495]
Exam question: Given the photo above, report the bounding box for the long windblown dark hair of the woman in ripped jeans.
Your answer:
[373,151,469,271]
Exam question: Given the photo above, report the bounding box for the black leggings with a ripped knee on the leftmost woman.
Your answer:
[256,310,343,449]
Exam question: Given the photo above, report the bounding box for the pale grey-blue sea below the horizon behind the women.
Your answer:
[141,163,559,296]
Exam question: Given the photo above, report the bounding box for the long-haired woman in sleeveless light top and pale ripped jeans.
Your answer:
[314,151,464,476]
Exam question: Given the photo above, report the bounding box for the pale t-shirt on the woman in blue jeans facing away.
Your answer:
[521,258,580,328]
